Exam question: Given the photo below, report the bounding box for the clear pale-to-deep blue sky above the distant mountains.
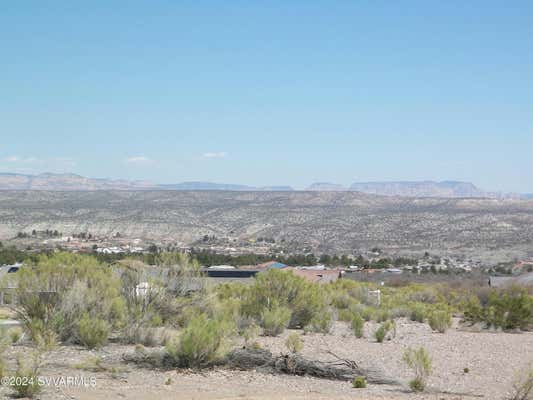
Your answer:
[0,0,533,192]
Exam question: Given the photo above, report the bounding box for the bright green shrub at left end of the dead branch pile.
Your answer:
[165,314,227,368]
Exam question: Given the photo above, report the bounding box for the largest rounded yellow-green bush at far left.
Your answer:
[12,253,125,345]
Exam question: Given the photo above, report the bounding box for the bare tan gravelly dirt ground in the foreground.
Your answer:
[0,320,533,400]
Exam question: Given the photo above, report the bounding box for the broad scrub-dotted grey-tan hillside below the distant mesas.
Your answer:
[0,191,533,261]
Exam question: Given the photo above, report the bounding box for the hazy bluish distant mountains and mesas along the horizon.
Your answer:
[0,173,533,199]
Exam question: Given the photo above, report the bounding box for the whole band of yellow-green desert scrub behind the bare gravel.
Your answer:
[10,248,532,387]
